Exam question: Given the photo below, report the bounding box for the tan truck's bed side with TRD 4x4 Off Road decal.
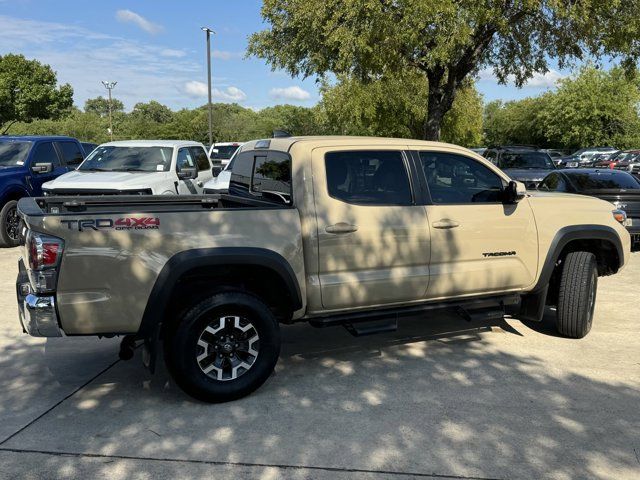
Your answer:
[18,195,305,335]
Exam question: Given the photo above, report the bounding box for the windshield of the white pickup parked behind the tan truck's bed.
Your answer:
[78,146,173,172]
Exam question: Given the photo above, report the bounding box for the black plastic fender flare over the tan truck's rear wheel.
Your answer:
[136,247,302,338]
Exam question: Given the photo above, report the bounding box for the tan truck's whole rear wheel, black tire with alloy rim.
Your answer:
[164,291,280,403]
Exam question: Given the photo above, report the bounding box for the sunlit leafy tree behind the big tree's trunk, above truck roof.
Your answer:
[318,71,482,146]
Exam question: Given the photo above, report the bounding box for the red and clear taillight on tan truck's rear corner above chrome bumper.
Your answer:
[26,231,64,293]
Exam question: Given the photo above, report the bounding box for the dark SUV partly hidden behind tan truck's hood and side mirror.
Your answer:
[484,145,556,190]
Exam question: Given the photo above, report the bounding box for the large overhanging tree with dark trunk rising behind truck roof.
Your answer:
[248,0,640,140]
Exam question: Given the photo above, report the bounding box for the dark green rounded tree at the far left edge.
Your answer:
[0,54,73,133]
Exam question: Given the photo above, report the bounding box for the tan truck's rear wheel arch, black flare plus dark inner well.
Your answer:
[137,247,303,338]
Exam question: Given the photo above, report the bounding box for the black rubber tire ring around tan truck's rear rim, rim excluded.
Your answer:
[165,292,280,402]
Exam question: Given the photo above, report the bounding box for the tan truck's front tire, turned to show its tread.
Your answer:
[556,252,598,338]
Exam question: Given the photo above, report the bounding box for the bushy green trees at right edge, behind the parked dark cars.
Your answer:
[484,66,640,149]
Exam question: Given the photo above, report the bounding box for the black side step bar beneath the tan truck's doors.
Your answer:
[309,295,520,335]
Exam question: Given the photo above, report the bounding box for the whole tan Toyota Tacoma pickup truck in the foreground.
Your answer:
[17,137,630,402]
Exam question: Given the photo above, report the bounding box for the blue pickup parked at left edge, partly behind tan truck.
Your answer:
[0,136,85,247]
